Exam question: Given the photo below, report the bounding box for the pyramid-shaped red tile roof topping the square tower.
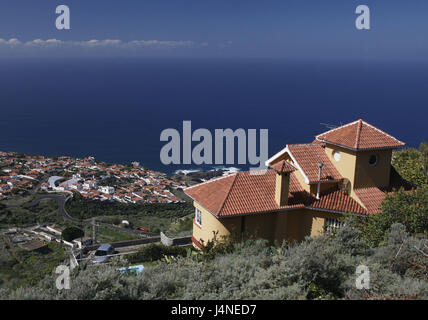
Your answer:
[316,119,404,150]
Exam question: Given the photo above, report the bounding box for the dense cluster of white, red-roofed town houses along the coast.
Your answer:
[0,151,186,203]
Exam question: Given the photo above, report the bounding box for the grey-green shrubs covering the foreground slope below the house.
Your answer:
[0,223,428,299]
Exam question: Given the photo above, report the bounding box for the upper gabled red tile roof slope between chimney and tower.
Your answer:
[287,143,342,183]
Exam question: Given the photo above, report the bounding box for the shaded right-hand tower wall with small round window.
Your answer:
[355,149,392,188]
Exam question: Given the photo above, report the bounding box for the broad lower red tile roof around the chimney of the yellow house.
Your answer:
[185,170,366,217]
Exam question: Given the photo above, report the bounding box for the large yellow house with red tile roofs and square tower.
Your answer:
[185,120,411,248]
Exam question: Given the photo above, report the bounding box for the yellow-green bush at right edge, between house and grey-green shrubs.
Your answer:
[362,186,428,246]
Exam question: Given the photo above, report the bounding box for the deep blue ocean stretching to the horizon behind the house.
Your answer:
[0,58,428,174]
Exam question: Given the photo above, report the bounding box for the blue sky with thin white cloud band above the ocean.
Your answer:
[0,0,428,61]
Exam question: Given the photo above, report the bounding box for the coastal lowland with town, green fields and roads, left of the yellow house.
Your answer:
[0,151,197,288]
